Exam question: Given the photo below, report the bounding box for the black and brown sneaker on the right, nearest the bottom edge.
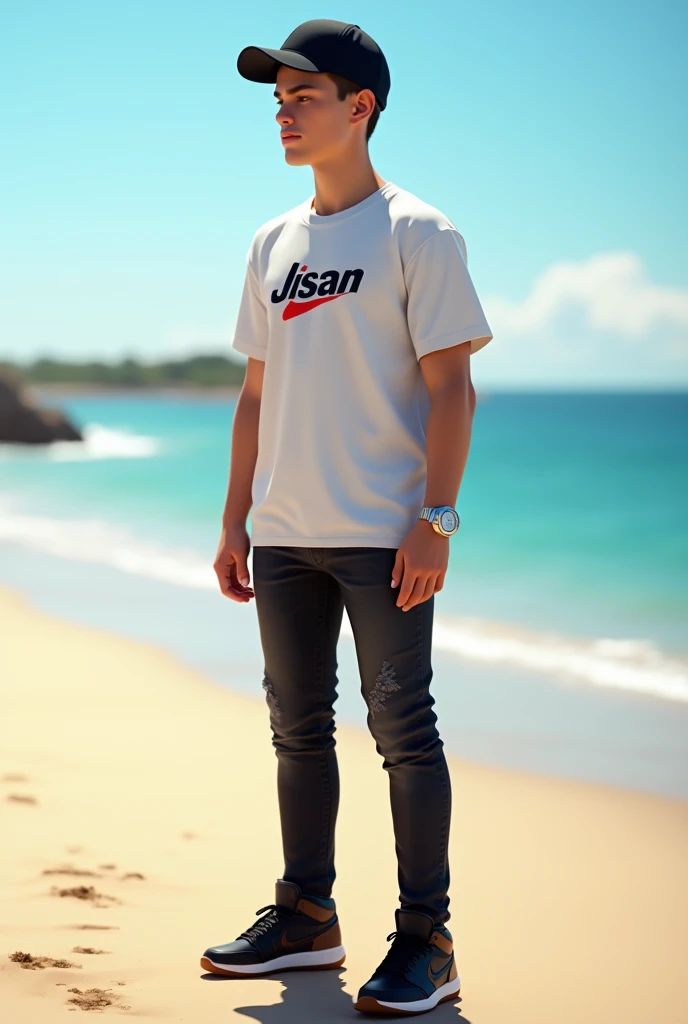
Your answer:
[354,909,461,1014]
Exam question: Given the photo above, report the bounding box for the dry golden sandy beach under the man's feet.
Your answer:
[0,590,688,1024]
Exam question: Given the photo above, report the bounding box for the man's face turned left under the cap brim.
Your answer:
[274,65,364,167]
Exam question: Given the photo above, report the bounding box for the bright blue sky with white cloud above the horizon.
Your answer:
[0,0,688,387]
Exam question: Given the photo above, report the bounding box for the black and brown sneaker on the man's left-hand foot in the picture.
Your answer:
[201,879,346,977]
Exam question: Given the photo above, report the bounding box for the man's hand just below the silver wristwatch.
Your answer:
[392,519,449,611]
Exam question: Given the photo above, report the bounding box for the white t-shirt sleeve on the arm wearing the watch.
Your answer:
[404,228,492,359]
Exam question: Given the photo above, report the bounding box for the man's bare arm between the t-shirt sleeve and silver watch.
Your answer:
[419,341,476,516]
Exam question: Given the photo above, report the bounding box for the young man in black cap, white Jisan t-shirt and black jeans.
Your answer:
[201,20,492,1014]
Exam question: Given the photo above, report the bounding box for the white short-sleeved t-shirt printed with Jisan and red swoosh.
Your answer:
[232,181,492,548]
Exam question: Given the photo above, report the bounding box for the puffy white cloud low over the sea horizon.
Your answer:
[476,252,688,386]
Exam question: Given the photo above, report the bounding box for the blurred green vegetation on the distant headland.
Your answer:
[0,355,244,388]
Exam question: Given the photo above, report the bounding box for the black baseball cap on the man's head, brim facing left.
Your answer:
[237,18,390,111]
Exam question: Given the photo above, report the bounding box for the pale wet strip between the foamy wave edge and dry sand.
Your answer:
[0,542,688,802]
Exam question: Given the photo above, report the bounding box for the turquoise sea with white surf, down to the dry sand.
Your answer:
[0,392,688,799]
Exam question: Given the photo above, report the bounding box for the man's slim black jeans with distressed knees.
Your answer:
[253,546,452,925]
